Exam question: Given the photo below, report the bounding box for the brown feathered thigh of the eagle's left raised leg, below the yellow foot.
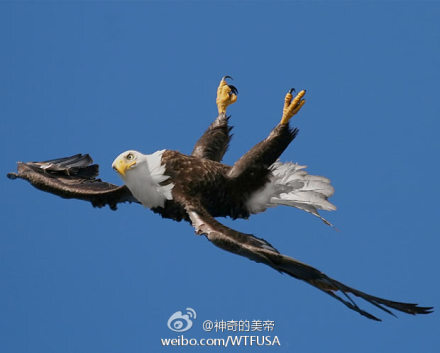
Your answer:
[191,113,232,162]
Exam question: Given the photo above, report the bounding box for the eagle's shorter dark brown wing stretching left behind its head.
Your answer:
[7,154,139,210]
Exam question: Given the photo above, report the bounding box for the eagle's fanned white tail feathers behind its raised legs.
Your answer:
[247,161,336,225]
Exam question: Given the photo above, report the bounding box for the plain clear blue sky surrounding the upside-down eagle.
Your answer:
[0,2,440,353]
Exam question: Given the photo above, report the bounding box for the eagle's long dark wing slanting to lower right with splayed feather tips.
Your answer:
[177,200,433,321]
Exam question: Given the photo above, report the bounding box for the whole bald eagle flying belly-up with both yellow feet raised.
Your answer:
[8,76,433,321]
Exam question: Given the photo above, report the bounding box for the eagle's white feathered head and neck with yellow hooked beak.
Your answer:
[112,150,174,208]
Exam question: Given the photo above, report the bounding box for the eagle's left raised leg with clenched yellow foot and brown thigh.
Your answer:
[191,76,238,162]
